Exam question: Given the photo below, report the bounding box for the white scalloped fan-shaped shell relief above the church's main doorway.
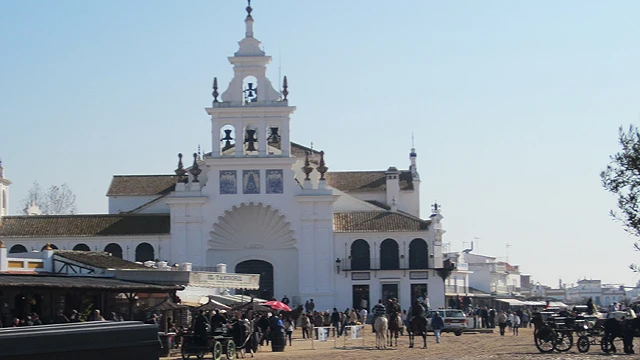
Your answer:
[209,202,296,250]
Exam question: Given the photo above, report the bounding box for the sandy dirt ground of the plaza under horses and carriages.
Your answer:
[166,326,640,360]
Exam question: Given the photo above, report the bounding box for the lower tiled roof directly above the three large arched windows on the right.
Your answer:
[333,211,431,232]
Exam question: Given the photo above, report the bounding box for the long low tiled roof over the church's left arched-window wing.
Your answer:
[0,214,171,237]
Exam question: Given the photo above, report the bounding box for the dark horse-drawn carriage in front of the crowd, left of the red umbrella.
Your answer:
[180,327,236,360]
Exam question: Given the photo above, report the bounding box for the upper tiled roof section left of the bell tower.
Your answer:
[107,175,178,196]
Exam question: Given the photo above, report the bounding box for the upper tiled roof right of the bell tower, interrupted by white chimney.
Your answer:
[325,170,413,192]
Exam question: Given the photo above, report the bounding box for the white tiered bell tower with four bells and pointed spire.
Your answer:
[206,1,296,159]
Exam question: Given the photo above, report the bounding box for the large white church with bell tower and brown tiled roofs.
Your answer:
[0,2,445,310]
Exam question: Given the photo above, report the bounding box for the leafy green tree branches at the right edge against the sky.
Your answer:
[600,125,640,258]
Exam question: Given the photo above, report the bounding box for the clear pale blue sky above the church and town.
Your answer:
[0,0,640,285]
